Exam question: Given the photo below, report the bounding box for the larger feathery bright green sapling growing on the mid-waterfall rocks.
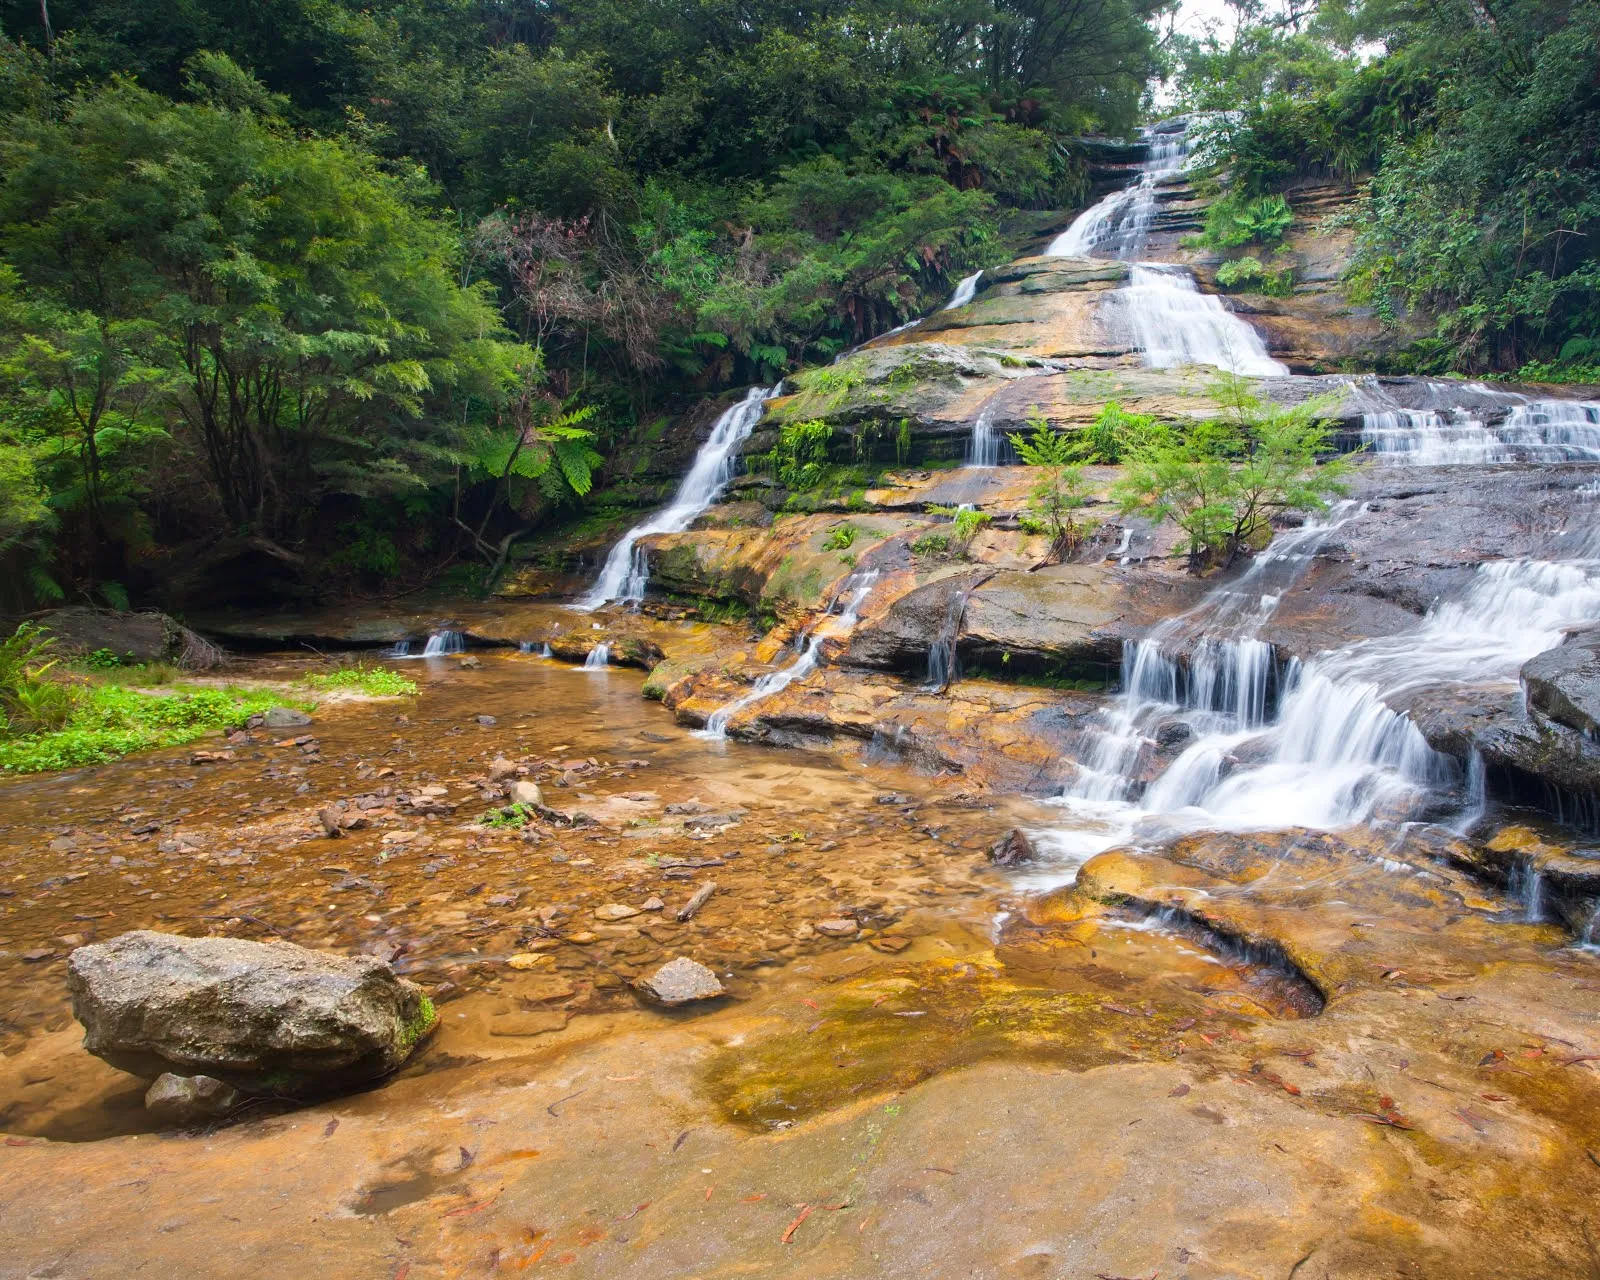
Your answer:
[1114,374,1349,574]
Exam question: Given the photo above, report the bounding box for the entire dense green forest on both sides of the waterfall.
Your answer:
[0,0,1600,611]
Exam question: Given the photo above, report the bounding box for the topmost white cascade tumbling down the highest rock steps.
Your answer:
[1045,120,1288,378]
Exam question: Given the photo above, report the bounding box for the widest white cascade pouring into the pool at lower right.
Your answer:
[1042,544,1600,874]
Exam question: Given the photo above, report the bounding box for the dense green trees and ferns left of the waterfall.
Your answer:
[0,0,1165,613]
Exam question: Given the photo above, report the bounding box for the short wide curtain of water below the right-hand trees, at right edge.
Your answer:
[1362,400,1600,467]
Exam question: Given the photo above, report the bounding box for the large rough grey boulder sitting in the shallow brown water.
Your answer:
[67,930,437,1098]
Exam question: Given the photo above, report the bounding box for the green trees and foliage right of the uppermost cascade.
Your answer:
[1179,0,1600,373]
